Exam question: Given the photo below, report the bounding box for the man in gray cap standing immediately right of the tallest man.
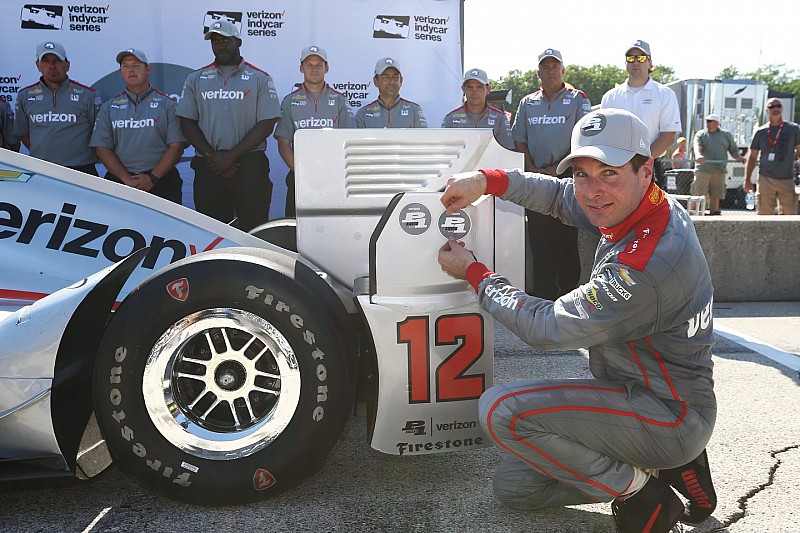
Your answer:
[275,45,355,217]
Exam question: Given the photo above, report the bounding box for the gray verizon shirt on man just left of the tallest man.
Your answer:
[89,88,186,174]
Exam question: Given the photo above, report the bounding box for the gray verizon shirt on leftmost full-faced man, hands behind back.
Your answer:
[14,78,100,167]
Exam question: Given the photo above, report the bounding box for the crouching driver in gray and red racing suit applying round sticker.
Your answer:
[439,109,716,533]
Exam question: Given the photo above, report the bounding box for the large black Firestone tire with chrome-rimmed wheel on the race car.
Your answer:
[94,248,357,505]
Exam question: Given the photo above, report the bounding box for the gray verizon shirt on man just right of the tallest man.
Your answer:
[275,85,355,141]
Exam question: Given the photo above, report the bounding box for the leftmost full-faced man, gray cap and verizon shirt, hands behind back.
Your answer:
[14,41,100,176]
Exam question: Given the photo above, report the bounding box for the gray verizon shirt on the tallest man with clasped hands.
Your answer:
[176,60,281,151]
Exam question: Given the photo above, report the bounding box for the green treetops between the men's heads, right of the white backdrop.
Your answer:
[492,65,676,119]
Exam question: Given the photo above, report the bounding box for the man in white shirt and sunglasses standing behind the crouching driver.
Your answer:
[600,40,681,184]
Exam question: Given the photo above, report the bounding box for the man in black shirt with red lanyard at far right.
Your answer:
[744,98,800,215]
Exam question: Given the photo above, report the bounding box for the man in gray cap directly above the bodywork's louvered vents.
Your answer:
[356,57,428,128]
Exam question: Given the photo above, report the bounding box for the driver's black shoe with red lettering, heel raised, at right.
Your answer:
[658,450,717,524]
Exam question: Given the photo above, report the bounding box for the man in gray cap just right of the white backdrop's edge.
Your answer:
[442,68,514,150]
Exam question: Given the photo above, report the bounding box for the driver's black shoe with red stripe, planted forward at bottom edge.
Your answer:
[611,477,684,533]
